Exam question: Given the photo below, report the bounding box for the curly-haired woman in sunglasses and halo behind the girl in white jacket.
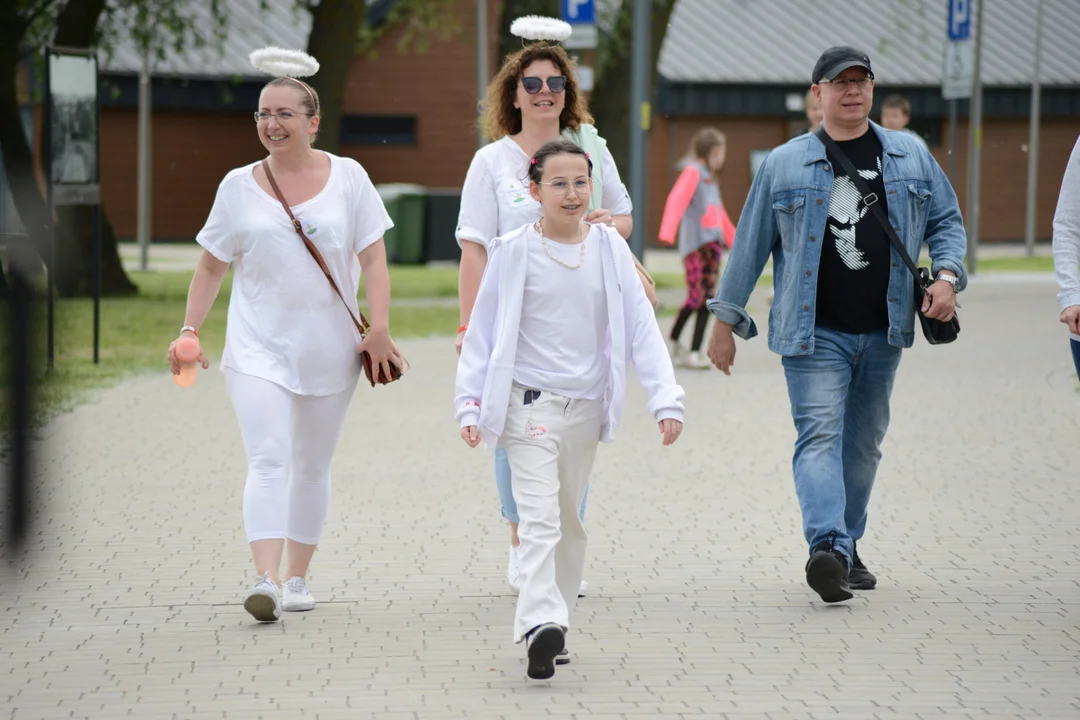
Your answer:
[456,17,633,595]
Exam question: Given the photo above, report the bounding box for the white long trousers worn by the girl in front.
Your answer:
[500,384,604,642]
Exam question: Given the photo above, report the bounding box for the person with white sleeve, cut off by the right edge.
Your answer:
[1053,133,1080,378]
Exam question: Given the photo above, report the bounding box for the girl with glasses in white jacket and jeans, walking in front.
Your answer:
[455,140,684,679]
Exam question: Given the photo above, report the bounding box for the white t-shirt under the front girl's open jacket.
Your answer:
[514,226,611,399]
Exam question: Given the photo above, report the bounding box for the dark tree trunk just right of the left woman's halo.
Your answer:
[308,0,367,153]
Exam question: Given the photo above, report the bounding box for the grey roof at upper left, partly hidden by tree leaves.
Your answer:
[98,0,313,77]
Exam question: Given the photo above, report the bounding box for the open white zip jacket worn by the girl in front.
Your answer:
[454,225,684,448]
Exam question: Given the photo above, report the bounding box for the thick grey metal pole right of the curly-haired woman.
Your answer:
[630,0,652,260]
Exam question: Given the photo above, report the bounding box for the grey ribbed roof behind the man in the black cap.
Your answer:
[659,0,1080,85]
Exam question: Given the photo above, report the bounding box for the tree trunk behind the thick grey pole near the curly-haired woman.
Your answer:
[589,0,675,178]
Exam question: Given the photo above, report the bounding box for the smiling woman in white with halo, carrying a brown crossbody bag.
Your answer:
[168,49,407,622]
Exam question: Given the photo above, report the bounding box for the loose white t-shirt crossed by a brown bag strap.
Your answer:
[195,153,393,395]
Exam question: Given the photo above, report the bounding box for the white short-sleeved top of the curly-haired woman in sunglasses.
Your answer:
[457,135,634,247]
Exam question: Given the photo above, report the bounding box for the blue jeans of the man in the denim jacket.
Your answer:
[783,328,902,561]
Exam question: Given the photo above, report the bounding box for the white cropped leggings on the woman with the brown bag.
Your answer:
[225,369,356,545]
